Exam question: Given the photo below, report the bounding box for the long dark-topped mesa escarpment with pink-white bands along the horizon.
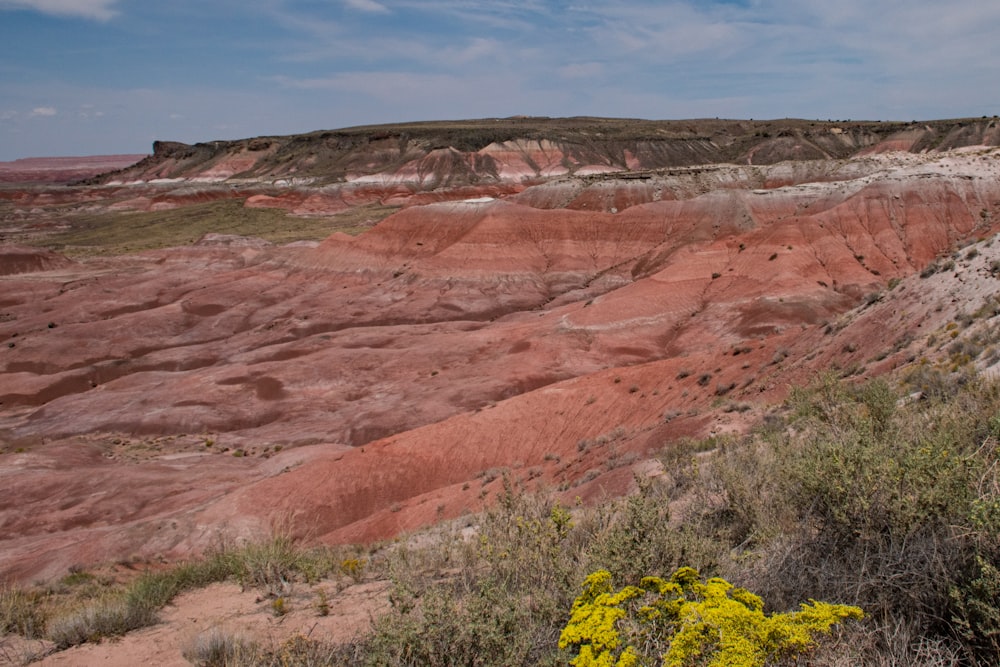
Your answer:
[91,117,1000,185]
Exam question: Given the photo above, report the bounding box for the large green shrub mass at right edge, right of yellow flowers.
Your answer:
[712,378,1000,660]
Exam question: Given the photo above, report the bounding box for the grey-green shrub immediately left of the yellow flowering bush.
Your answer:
[350,476,582,666]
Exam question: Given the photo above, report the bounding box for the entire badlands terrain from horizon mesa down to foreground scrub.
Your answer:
[0,119,1000,579]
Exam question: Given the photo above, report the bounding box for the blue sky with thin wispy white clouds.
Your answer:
[0,0,1000,161]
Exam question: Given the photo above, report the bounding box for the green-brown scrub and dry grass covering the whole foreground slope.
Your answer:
[0,376,1000,667]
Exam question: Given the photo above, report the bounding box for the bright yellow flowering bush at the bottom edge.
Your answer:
[559,567,863,667]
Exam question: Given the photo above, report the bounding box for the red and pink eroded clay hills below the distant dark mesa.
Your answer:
[0,153,1000,576]
